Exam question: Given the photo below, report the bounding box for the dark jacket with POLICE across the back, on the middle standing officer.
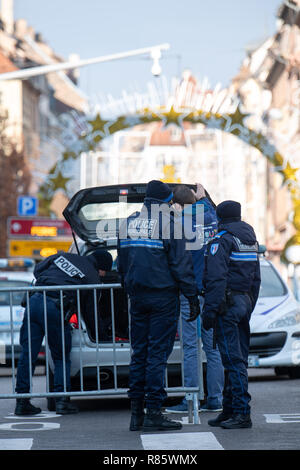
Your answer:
[118,198,197,297]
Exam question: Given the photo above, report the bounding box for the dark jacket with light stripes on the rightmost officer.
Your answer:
[204,221,261,312]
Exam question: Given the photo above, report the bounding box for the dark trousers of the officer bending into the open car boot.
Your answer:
[16,293,72,393]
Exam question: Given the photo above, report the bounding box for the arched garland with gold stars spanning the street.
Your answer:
[39,105,300,263]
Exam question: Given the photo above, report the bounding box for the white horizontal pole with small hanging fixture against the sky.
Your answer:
[0,43,170,81]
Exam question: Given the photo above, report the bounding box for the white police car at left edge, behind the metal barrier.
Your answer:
[0,259,34,366]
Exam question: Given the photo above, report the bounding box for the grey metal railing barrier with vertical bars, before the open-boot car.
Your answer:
[0,284,204,424]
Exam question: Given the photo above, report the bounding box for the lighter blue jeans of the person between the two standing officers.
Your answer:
[180,295,224,406]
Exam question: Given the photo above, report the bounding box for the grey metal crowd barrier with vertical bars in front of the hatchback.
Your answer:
[0,284,204,424]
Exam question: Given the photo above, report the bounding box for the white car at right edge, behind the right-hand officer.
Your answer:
[248,256,300,378]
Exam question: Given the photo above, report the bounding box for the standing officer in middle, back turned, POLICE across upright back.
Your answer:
[118,180,200,431]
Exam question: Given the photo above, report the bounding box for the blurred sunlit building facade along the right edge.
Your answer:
[232,0,300,272]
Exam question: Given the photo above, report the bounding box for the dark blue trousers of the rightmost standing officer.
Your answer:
[217,294,252,414]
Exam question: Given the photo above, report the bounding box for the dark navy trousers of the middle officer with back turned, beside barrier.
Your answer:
[128,291,179,409]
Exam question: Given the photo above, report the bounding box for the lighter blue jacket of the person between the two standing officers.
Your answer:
[182,198,218,292]
